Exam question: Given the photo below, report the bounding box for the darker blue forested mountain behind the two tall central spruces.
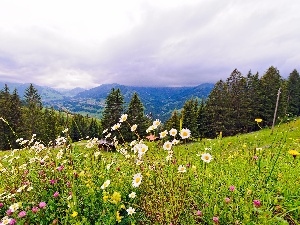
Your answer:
[75,83,214,121]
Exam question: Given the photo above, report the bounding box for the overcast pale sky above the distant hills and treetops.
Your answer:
[0,0,300,89]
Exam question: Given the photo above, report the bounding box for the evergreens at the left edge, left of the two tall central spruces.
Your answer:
[0,84,102,150]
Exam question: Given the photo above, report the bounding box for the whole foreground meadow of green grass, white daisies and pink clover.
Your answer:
[0,115,300,225]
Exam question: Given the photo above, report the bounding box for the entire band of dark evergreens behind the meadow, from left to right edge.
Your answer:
[0,66,300,149]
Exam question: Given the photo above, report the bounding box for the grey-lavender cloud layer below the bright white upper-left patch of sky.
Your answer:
[0,0,300,87]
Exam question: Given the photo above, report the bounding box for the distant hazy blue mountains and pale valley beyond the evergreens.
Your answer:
[0,82,214,121]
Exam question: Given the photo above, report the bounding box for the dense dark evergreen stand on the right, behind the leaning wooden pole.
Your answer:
[165,66,300,138]
